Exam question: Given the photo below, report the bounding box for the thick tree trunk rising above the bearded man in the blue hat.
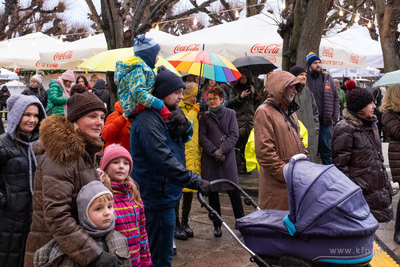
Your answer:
[295,0,332,69]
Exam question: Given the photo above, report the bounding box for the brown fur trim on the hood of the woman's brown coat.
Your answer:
[39,115,103,165]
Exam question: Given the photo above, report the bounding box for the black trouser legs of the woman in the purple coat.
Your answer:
[208,190,244,227]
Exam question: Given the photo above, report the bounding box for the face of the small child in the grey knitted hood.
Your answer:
[88,198,114,229]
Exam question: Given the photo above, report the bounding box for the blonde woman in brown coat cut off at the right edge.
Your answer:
[380,84,400,244]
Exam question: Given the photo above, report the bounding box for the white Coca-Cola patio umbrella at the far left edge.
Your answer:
[0,32,62,69]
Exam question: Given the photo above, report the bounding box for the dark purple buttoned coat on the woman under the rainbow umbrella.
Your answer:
[199,107,239,192]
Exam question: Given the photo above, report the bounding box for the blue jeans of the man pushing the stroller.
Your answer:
[145,208,175,267]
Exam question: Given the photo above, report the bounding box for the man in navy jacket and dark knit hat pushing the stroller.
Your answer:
[130,69,211,266]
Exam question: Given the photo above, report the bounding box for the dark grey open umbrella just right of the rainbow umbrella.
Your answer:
[232,56,277,75]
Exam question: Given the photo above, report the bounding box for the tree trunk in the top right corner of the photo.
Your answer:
[375,0,400,73]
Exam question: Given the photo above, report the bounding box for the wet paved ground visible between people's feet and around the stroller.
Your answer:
[172,144,400,267]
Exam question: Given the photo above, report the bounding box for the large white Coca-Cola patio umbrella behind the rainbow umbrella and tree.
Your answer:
[160,14,367,68]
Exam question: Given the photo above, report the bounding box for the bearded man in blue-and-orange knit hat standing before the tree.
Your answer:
[306,52,340,165]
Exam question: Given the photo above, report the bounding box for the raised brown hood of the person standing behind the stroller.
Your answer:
[265,70,301,109]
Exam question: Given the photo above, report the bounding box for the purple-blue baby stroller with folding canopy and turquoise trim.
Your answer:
[198,154,378,267]
